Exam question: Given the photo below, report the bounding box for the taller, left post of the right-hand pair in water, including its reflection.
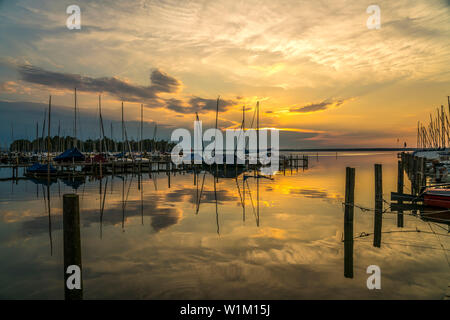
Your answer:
[344,167,355,278]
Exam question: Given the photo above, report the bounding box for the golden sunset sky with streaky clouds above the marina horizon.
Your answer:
[0,0,450,148]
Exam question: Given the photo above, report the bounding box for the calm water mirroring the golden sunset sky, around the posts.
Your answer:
[0,153,450,299]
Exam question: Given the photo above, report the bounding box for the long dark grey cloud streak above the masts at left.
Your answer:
[18,65,181,102]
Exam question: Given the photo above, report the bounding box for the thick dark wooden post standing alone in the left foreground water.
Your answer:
[63,194,83,300]
